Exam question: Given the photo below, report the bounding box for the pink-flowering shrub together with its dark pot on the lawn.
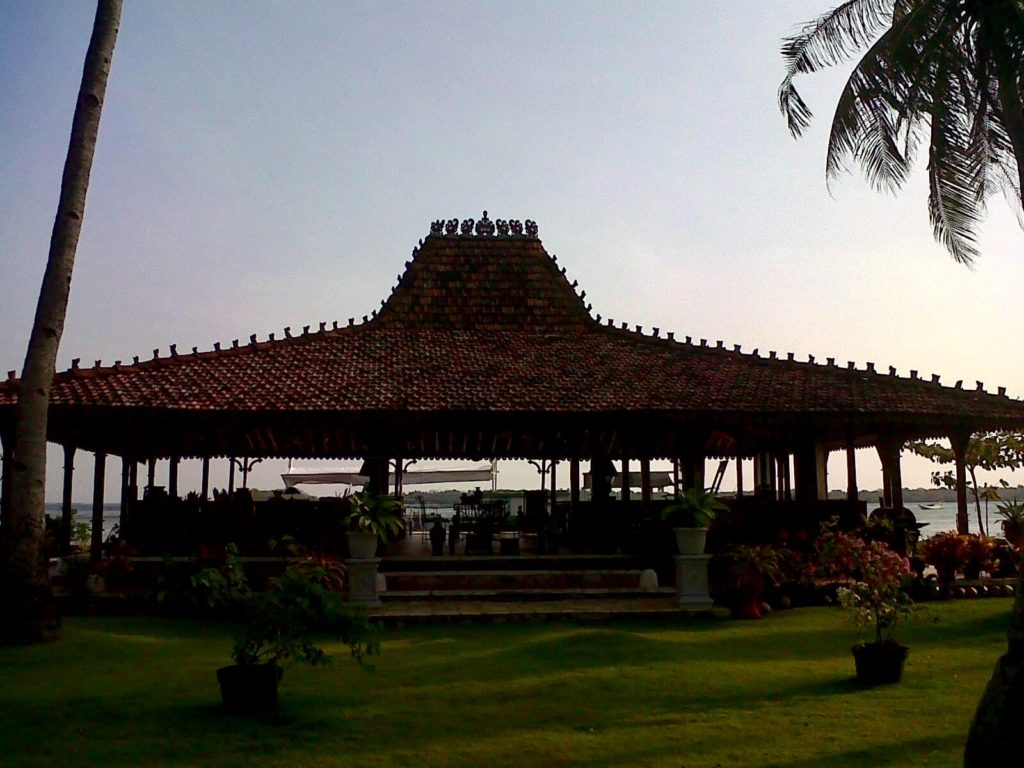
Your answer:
[818,529,911,685]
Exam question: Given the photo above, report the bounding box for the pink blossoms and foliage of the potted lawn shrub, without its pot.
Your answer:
[817,528,911,643]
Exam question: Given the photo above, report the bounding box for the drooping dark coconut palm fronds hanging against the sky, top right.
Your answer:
[779,0,1024,264]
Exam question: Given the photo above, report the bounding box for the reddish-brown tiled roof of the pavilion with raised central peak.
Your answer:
[0,225,1024,430]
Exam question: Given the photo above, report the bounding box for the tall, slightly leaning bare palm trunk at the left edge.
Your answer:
[0,0,121,642]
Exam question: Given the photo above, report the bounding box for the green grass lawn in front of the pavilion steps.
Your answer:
[0,599,1011,768]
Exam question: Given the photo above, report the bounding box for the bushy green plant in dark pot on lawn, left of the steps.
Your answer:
[217,556,378,714]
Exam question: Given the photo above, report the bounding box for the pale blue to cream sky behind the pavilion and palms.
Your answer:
[0,0,1024,501]
